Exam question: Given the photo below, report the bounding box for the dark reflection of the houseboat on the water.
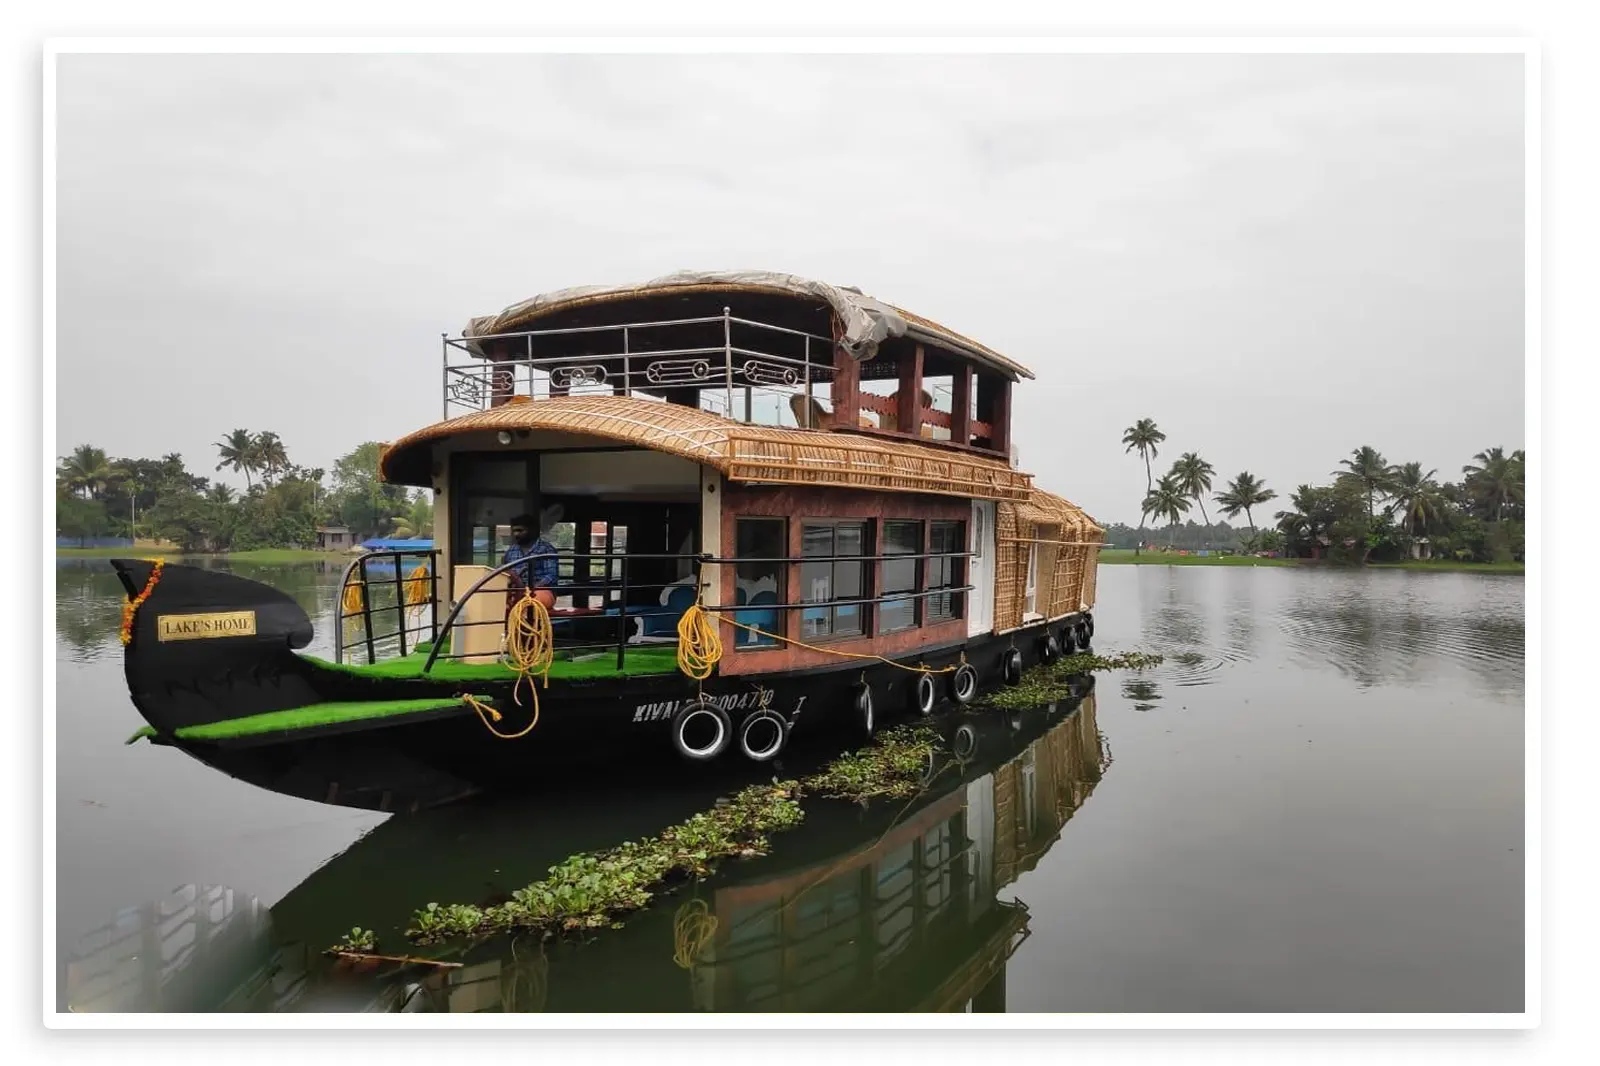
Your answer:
[69,693,1109,1012]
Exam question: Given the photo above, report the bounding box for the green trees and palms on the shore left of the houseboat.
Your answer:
[56,429,434,551]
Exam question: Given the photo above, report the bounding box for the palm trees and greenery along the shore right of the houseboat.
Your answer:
[1106,418,1526,563]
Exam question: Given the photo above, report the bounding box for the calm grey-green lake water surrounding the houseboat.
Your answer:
[56,560,1523,1012]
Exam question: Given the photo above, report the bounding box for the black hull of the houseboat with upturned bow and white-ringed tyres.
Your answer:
[114,560,1083,812]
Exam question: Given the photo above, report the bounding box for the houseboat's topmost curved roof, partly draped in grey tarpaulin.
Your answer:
[462,271,1034,378]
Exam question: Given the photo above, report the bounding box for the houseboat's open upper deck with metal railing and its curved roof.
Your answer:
[443,274,1032,458]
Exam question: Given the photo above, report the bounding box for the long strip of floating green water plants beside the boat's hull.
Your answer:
[406,727,939,944]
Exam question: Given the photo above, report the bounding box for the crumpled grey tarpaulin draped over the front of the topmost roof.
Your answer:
[464,271,907,359]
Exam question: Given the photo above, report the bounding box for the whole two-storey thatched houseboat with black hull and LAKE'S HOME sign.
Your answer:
[114,272,1104,810]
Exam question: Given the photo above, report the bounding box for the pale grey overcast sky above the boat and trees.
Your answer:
[54,56,1523,522]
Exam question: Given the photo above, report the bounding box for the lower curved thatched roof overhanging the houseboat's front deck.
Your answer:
[379,395,1035,501]
